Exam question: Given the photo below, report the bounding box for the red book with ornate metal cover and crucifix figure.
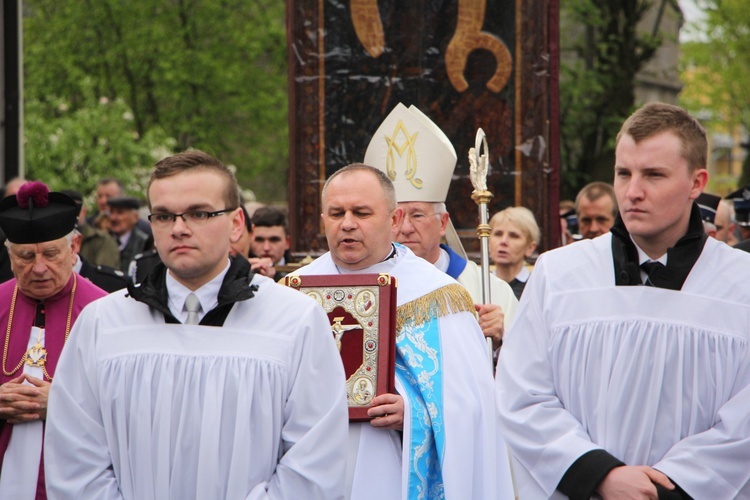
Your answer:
[284,274,396,421]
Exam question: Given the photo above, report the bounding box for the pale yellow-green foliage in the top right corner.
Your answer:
[680,0,750,189]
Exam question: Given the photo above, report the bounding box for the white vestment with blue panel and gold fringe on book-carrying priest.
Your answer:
[294,244,513,500]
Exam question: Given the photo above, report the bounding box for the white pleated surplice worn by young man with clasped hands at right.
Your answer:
[497,234,750,500]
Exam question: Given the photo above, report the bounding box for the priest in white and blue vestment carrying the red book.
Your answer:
[292,163,513,500]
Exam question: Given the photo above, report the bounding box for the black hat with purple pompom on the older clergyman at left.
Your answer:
[0,181,78,244]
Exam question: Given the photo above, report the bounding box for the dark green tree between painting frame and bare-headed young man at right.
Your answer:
[560,0,666,198]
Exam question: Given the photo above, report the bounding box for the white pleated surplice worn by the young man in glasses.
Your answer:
[45,275,347,500]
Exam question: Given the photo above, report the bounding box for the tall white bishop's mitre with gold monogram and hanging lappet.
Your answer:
[364,103,466,257]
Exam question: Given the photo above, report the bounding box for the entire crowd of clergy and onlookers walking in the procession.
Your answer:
[0,103,750,500]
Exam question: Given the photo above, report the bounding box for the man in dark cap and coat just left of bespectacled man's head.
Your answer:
[107,196,151,273]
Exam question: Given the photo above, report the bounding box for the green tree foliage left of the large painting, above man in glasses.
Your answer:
[24,0,288,200]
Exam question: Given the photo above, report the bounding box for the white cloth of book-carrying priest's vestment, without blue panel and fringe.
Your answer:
[294,244,513,500]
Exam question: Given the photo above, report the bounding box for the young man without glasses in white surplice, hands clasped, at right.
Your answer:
[496,103,750,500]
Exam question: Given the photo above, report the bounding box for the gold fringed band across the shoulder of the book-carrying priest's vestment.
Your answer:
[396,283,476,331]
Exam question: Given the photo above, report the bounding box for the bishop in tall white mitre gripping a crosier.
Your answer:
[365,103,518,348]
